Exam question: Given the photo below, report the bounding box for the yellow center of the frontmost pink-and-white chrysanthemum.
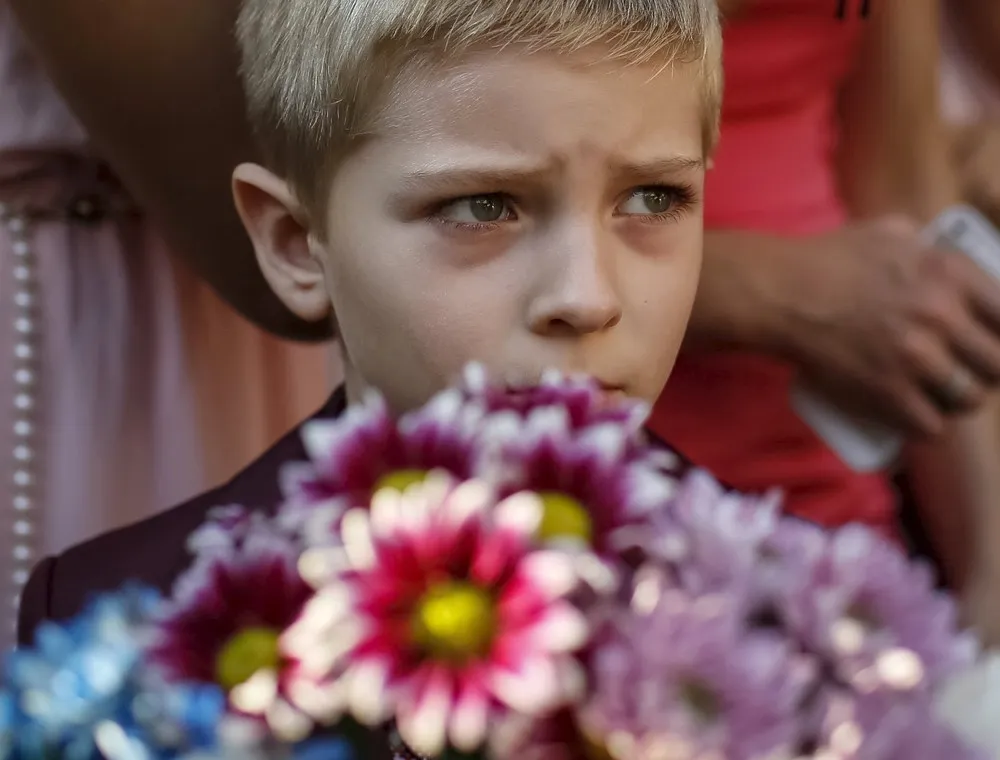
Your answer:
[411,581,496,662]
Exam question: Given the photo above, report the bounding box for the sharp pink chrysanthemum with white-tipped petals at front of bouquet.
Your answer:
[283,474,587,756]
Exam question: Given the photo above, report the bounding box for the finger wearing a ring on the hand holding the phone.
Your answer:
[903,330,985,414]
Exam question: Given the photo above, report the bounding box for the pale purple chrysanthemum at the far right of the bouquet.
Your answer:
[779,525,976,692]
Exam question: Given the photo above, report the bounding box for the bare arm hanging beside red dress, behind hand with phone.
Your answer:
[842,0,1000,616]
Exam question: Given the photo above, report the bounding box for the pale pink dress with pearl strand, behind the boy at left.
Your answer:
[0,0,335,647]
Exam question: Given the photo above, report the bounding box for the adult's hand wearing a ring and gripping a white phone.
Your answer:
[768,218,1000,435]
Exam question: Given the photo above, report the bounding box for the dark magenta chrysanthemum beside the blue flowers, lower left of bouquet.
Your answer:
[150,507,313,741]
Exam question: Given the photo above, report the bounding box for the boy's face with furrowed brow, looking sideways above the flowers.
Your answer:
[236,48,705,410]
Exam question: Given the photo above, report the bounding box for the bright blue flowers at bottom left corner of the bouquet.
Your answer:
[0,587,224,760]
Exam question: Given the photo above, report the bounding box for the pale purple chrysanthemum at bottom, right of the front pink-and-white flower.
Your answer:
[581,590,815,760]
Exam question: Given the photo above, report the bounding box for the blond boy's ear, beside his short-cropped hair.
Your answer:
[233,164,331,322]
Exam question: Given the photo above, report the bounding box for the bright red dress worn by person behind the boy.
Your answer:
[651,0,894,532]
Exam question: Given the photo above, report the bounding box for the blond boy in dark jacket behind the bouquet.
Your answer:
[19,0,721,664]
